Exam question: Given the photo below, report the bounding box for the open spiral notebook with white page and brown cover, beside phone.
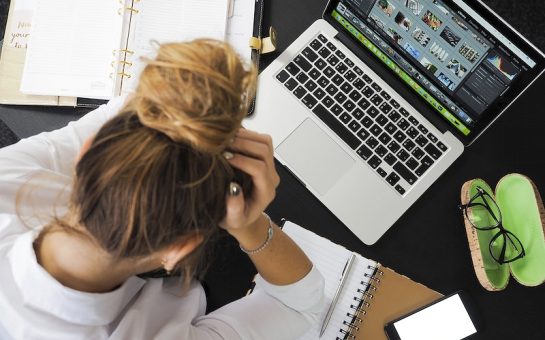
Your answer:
[282,222,441,340]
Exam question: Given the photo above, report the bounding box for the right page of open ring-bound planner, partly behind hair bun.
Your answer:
[122,0,230,92]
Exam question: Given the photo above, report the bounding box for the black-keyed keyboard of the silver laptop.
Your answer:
[276,34,448,195]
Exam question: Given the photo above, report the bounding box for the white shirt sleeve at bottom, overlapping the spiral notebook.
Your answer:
[190,267,324,340]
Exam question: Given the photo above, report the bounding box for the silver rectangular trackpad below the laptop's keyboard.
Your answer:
[276,118,354,195]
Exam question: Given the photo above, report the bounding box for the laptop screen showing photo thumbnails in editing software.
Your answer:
[325,0,543,141]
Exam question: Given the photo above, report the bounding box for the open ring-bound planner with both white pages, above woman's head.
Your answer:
[21,0,230,99]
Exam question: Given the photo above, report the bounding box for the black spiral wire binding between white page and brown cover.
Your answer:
[337,263,384,340]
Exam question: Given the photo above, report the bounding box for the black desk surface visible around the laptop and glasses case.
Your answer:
[0,0,545,340]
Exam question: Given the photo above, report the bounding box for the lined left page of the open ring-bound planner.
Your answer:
[21,0,123,99]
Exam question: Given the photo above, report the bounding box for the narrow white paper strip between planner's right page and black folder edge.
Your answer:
[225,0,256,64]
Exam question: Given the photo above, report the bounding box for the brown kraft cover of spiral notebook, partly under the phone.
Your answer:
[352,265,442,340]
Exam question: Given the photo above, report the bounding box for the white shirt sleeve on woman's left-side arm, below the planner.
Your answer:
[0,96,126,224]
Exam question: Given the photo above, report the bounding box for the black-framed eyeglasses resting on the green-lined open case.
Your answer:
[458,186,526,264]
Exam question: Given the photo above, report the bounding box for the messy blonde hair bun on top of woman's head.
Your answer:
[128,39,256,153]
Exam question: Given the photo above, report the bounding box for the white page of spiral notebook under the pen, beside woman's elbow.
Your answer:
[283,222,377,340]
